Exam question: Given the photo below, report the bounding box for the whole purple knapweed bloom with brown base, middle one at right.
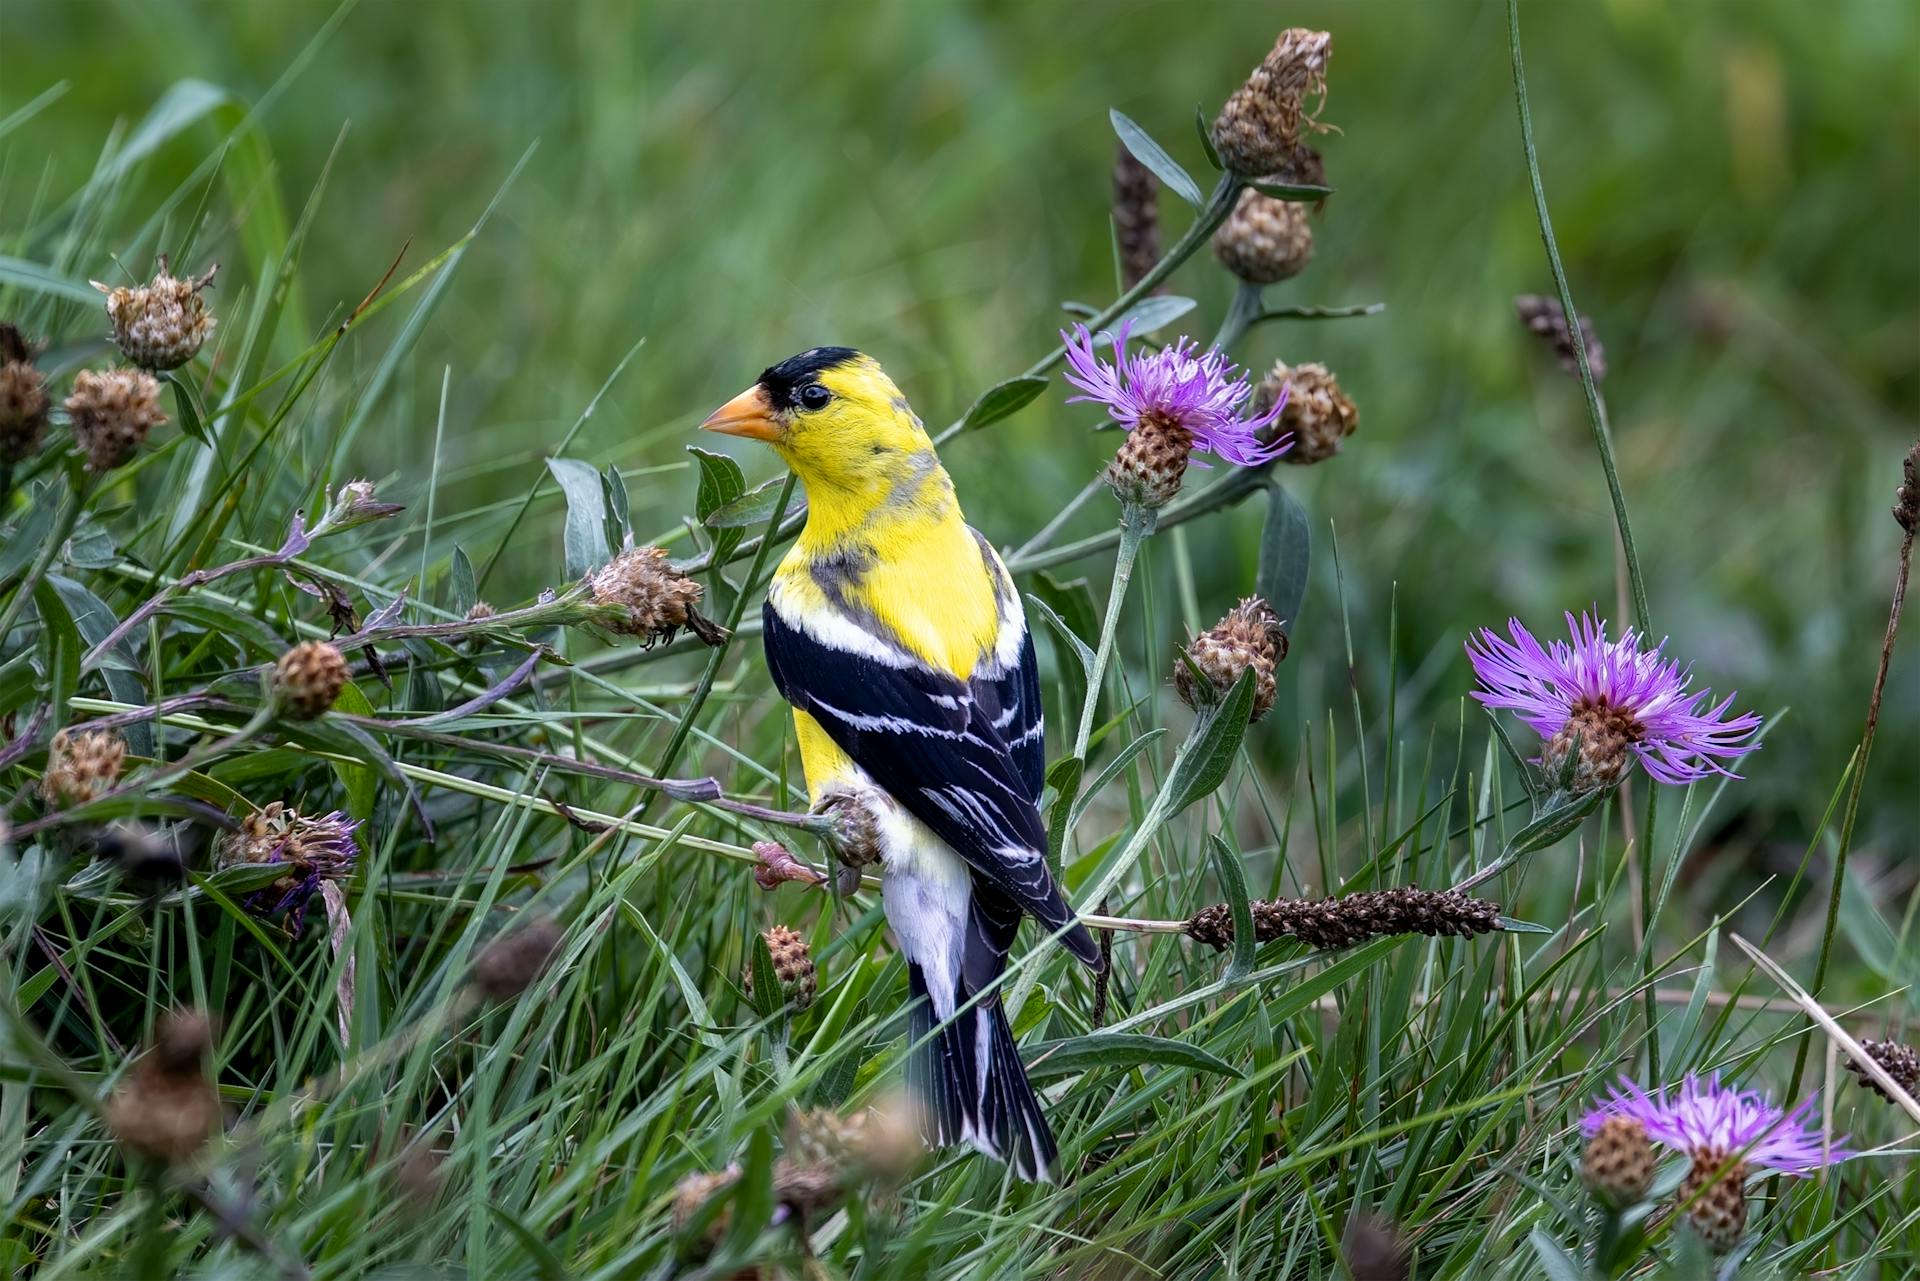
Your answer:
[1467,615,1761,791]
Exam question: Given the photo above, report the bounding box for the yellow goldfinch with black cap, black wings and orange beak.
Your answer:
[701,348,1106,1181]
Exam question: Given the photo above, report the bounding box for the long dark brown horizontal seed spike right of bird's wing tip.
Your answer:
[1187,887,1501,951]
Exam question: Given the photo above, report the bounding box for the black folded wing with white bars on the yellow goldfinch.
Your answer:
[762,601,1100,966]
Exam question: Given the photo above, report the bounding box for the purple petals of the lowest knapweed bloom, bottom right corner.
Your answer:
[1580,1074,1853,1175]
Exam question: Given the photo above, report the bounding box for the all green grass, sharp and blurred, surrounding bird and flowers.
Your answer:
[0,0,1920,1279]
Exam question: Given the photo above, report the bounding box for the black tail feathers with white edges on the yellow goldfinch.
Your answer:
[906,964,1060,1183]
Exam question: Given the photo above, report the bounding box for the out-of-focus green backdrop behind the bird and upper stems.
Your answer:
[0,0,1920,916]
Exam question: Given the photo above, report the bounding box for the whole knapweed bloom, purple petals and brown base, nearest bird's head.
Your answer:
[1060,321,1292,507]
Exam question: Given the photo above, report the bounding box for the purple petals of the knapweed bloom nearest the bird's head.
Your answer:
[1060,321,1292,467]
